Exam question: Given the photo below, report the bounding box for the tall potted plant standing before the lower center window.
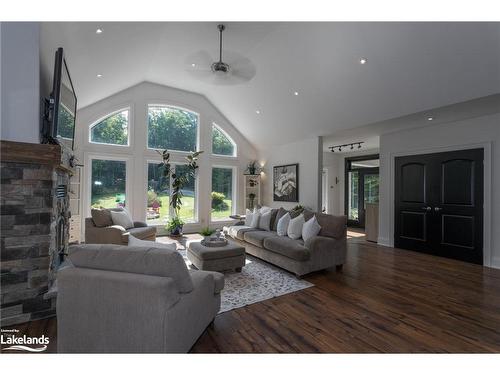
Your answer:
[157,150,203,236]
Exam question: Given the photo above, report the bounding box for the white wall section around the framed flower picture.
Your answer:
[259,137,322,210]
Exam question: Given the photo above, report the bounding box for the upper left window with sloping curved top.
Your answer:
[90,109,129,146]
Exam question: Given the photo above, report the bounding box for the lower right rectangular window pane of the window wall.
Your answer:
[211,167,233,221]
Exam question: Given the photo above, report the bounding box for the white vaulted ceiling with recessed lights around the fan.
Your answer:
[41,22,500,150]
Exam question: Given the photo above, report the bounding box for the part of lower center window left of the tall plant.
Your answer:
[146,163,170,225]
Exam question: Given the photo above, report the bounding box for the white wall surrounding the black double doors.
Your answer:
[378,114,500,268]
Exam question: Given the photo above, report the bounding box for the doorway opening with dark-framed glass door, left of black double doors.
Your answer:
[344,154,380,228]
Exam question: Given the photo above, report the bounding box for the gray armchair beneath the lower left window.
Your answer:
[85,217,156,245]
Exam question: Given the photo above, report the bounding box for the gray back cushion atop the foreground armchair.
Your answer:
[69,245,193,293]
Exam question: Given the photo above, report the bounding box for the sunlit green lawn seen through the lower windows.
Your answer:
[91,194,232,222]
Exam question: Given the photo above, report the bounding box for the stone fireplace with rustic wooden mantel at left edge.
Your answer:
[0,141,73,327]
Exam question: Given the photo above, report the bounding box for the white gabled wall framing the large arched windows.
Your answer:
[75,82,256,232]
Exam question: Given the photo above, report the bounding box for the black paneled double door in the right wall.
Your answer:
[394,149,483,264]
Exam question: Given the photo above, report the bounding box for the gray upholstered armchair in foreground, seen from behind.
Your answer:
[57,245,224,353]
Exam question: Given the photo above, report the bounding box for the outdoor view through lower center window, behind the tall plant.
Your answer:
[146,163,196,225]
